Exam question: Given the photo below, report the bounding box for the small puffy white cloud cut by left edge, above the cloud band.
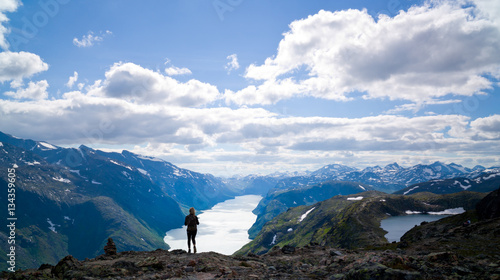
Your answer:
[0,52,49,82]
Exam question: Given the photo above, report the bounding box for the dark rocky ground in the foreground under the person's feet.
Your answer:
[3,244,500,280]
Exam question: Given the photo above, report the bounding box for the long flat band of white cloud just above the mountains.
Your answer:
[0,80,500,174]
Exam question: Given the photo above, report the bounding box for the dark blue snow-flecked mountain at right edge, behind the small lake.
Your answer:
[395,168,500,195]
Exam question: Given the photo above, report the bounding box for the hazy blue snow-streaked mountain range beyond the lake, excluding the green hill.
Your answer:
[0,132,500,269]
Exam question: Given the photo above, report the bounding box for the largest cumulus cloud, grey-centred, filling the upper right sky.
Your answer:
[226,1,500,104]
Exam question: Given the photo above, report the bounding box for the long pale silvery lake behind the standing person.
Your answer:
[164,195,262,255]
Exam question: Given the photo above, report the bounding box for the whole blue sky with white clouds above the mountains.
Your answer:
[0,0,500,176]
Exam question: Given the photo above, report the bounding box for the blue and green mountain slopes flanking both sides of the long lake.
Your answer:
[0,133,500,270]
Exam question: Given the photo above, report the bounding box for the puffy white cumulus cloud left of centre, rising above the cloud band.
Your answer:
[96,63,220,107]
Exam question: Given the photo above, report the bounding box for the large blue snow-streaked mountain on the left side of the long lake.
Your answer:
[0,133,234,269]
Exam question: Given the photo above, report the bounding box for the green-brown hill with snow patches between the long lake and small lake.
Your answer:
[235,191,486,255]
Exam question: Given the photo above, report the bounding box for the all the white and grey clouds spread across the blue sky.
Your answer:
[0,1,500,174]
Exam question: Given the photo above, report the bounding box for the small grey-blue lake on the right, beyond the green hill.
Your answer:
[380,214,451,242]
